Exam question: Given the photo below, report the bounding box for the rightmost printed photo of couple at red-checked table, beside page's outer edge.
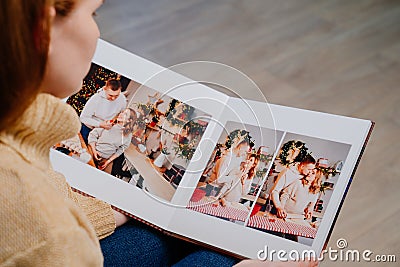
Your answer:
[247,133,351,245]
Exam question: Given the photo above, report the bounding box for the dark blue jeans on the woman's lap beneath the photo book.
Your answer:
[100,220,237,267]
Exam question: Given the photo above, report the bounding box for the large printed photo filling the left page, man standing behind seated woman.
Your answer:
[55,63,210,201]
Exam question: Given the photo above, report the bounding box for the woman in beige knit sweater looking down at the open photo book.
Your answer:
[0,0,316,266]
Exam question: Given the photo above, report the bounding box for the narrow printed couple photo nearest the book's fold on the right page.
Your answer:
[188,122,283,225]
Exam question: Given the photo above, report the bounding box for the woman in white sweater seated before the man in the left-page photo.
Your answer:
[88,108,137,174]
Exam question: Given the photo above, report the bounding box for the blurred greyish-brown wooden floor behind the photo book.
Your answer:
[97,0,400,266]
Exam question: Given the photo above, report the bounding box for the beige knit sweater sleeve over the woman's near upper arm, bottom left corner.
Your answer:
[0,167,102,267]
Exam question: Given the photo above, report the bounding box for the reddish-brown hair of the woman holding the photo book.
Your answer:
[0,0,74,131]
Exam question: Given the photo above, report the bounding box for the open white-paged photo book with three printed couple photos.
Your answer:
[50,40,374,258]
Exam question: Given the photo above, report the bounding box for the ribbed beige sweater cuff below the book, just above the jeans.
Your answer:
[72,191,116,239]
